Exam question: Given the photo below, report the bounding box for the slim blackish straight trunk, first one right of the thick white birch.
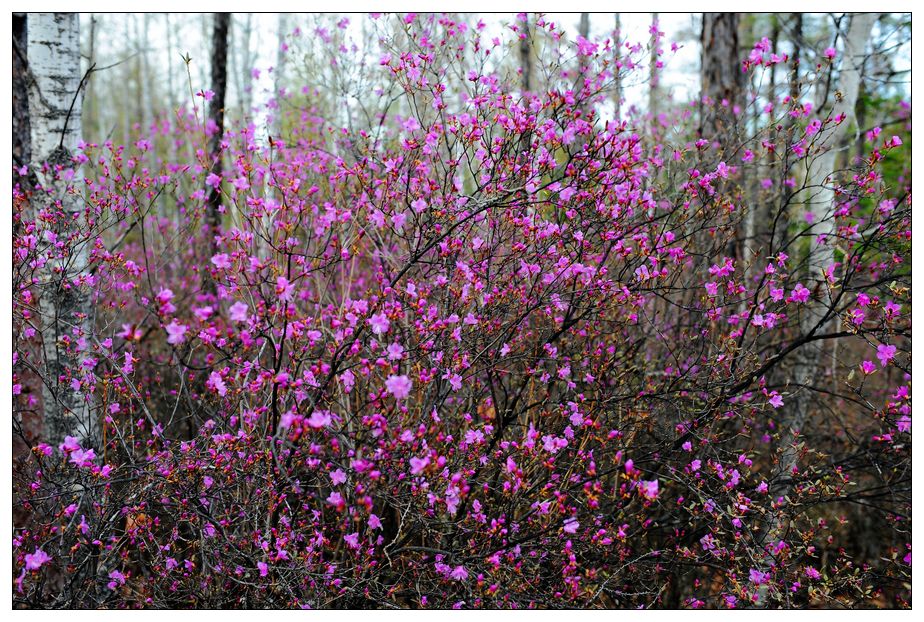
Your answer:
[206,13,231,268]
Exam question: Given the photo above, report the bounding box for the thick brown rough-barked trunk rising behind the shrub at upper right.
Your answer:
[699,13,745,148]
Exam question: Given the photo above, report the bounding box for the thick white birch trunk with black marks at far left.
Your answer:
[27,13,95,445]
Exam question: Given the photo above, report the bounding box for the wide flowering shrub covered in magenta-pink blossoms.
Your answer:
[13,16,911,608]
